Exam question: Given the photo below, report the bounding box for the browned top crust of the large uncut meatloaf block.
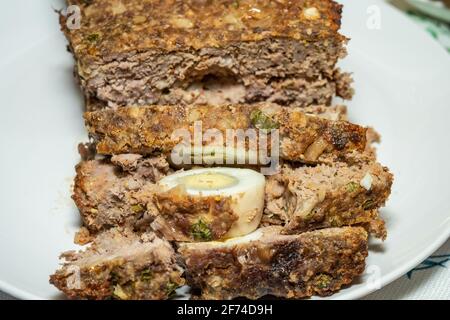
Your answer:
[61,0,345,61]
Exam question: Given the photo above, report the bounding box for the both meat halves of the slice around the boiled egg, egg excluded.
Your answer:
[73,155,392,241]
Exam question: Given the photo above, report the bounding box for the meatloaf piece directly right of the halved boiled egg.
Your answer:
[262,162,393,237]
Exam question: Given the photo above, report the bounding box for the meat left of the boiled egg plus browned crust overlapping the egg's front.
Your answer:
[72,154,238,243]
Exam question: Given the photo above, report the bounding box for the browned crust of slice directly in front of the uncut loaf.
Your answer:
[85,105,366,163]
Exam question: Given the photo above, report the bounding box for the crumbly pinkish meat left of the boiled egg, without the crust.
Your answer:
[72,155,172,233]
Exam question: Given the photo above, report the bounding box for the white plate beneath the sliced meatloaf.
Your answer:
[0,0,450,299]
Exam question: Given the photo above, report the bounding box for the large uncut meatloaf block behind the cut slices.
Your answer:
[61,0,352,107]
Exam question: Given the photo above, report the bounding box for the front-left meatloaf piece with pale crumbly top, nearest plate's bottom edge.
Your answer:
[50,228,184,300]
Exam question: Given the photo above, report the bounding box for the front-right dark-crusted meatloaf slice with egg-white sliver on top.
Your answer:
[178,227,367,299]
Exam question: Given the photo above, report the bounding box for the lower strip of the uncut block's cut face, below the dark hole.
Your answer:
[86,71,353,111]
